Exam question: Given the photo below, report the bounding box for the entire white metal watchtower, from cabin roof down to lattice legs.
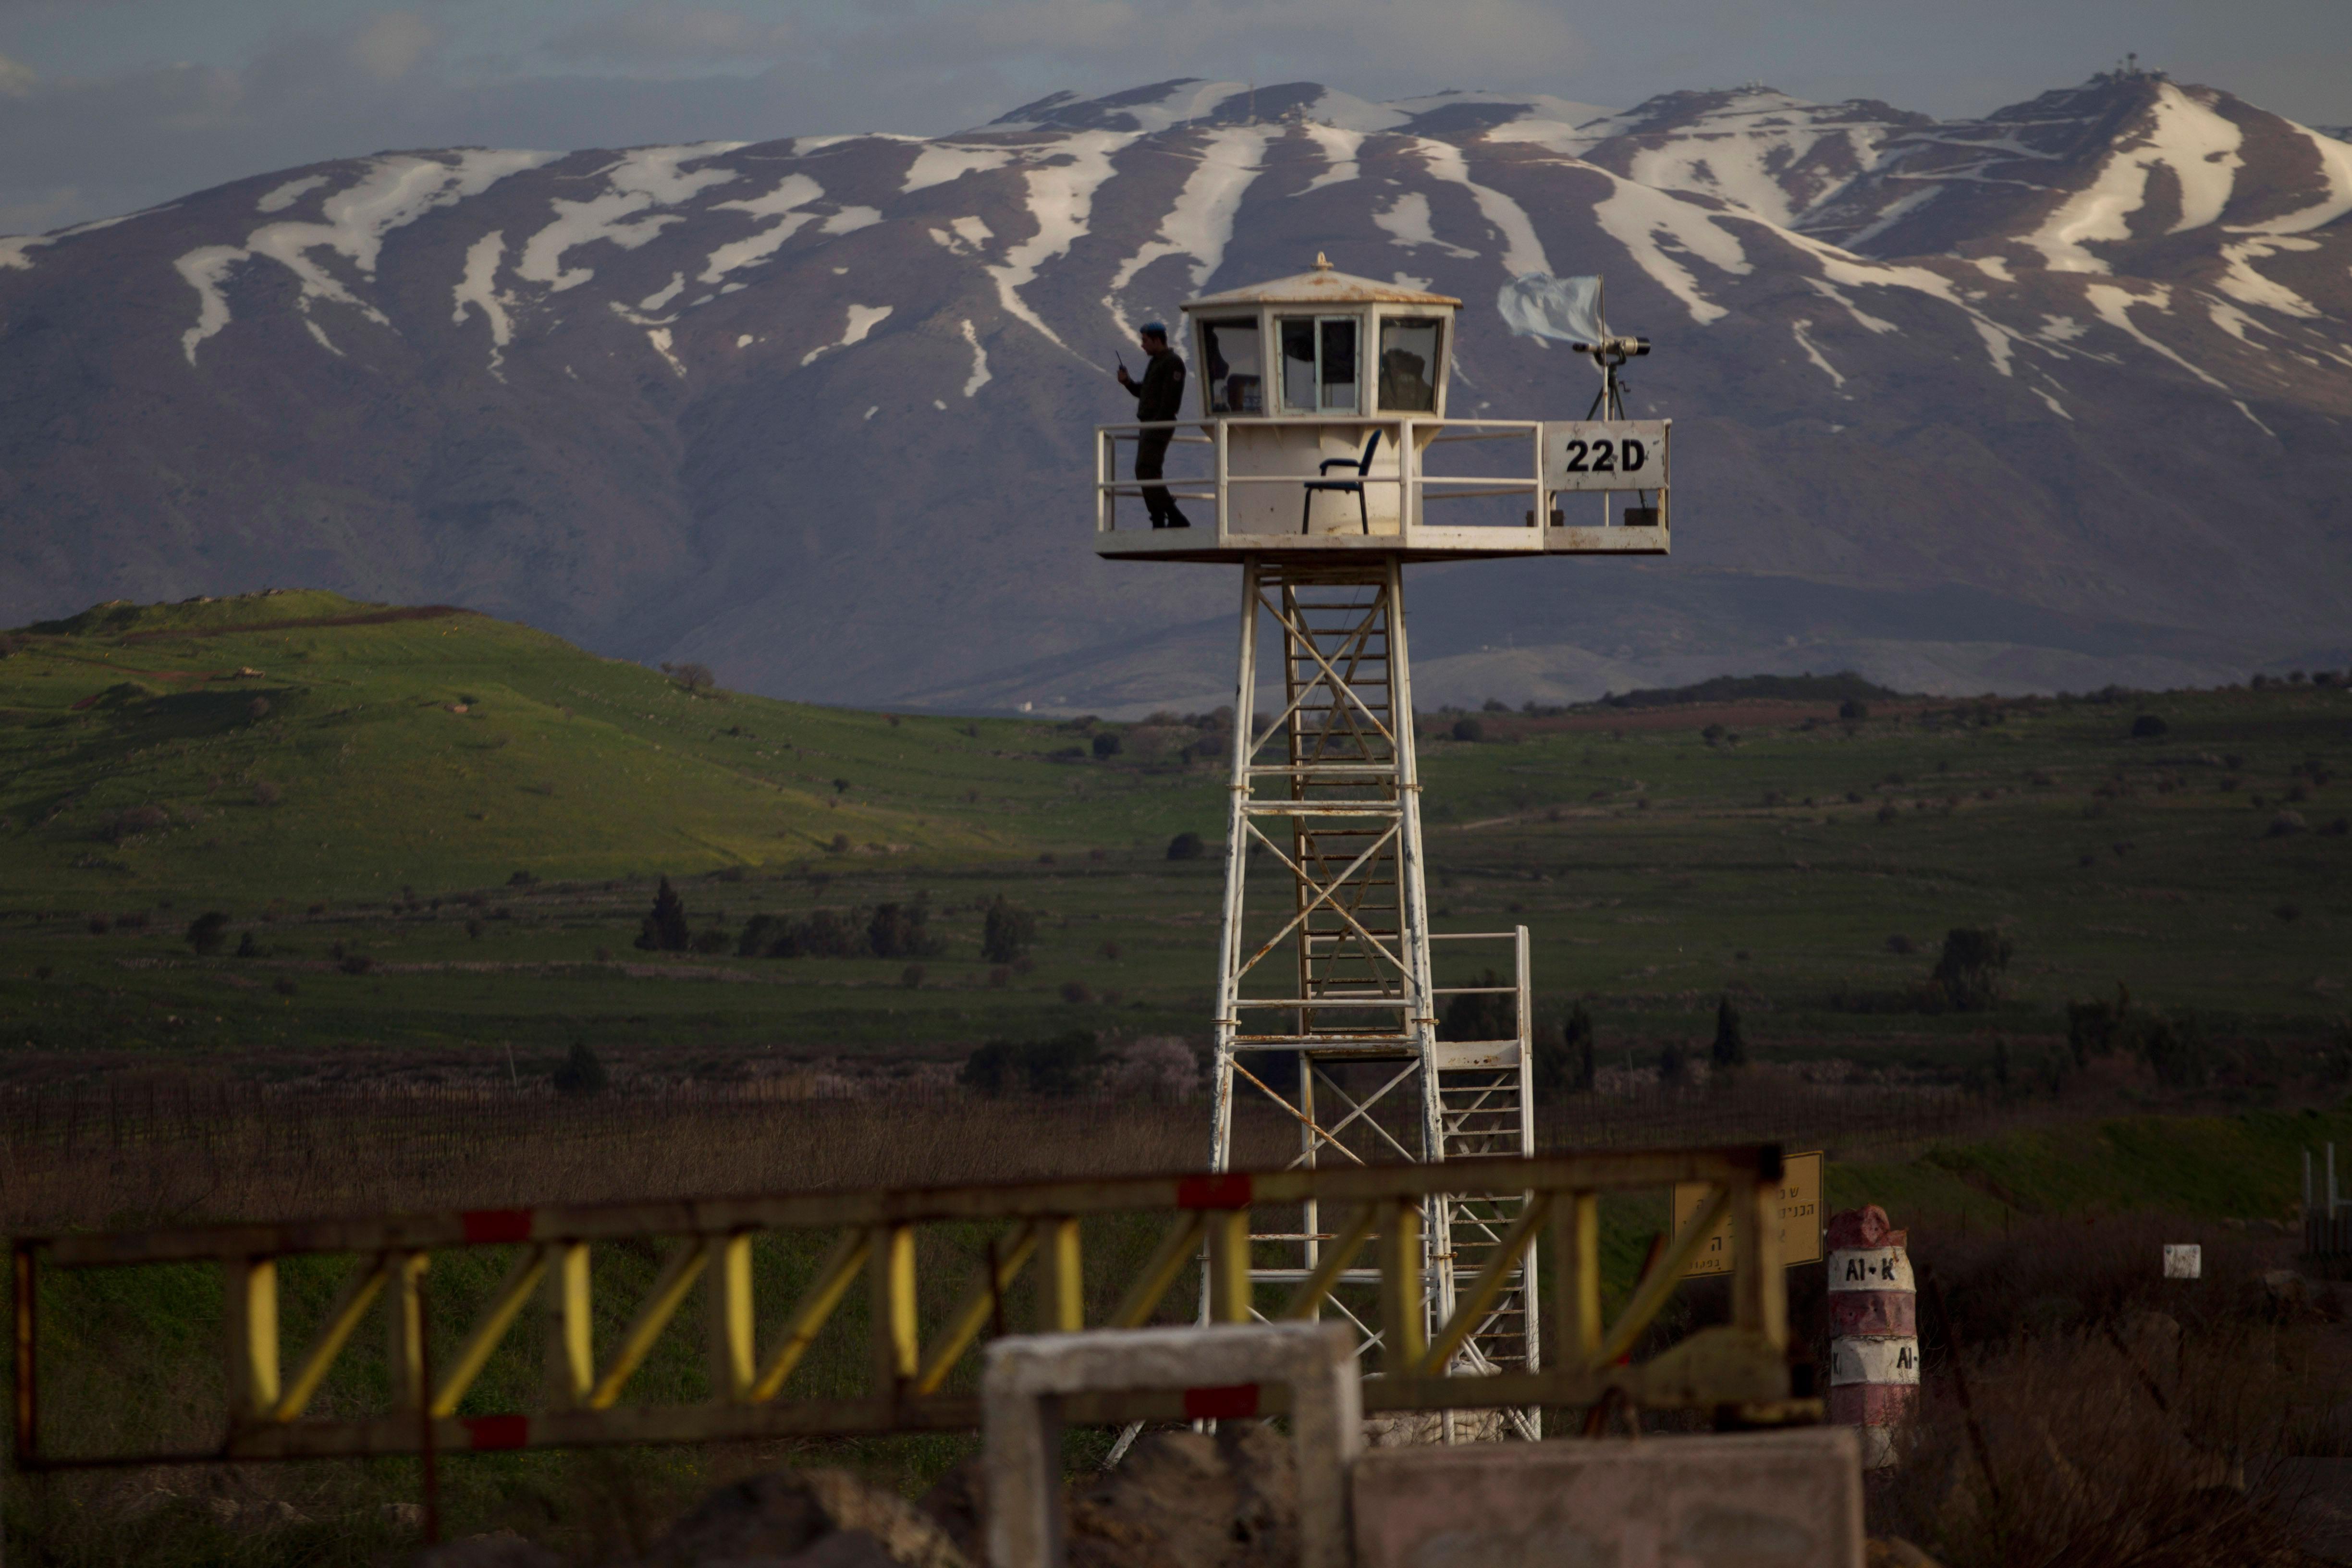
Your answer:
[1094,256,1670,1436]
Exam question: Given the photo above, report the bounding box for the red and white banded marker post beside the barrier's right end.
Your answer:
[1825,1203,1919,1469]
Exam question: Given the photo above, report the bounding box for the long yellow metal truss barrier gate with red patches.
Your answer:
[12,1145,1811,1469]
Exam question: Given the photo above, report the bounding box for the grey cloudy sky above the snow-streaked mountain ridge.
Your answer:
[0,0,2352,233]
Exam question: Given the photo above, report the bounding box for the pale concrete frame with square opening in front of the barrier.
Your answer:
[981,1323,1364,1568]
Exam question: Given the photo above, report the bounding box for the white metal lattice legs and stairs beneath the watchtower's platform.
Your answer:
[1209,557,1541,1436]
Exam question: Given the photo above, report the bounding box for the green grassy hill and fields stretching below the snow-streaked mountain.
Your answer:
[0,592,2352,1074]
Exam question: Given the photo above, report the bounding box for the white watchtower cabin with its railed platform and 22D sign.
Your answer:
[1094,256,1672,562]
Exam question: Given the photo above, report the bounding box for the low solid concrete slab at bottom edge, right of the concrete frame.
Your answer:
[1352,1427,1863,1568]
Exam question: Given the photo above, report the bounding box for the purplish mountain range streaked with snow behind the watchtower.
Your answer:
[0,73,2352,712]
